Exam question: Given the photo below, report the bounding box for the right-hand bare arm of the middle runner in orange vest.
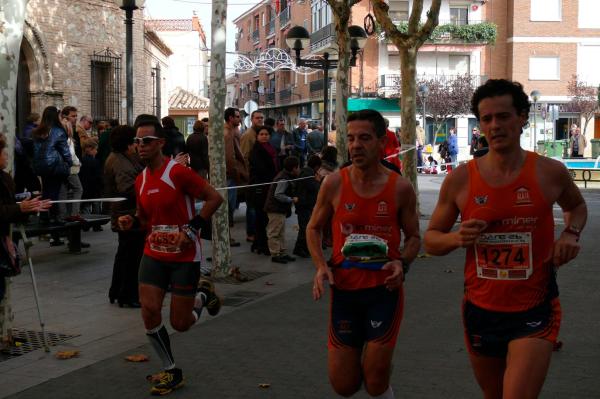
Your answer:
[398,179,421,263]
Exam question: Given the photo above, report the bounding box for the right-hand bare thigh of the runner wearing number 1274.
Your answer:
[504,338,553,399]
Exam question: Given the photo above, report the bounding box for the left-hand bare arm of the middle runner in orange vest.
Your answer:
[306,172,341,300]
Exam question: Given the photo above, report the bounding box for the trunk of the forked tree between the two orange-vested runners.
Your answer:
[398,46,419,198]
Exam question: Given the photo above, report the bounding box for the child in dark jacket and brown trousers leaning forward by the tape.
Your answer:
[264,156,300,263]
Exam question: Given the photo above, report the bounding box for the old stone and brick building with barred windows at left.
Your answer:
[17,0,170,134]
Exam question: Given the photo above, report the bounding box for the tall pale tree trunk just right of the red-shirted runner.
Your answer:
[208,0,231,276]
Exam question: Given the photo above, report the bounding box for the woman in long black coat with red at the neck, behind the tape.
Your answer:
[249,126,279,256]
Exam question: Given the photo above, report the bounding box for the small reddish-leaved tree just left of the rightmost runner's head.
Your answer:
[418,75,475,137]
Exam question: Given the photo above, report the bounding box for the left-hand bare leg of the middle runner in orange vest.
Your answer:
[328,347,362,397]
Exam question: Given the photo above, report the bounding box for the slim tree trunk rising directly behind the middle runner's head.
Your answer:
[333,10,350,165]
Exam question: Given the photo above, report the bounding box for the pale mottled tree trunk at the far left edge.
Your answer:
[0,0,27,347]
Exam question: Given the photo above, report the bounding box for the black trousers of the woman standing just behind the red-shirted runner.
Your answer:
[108,231,146,303]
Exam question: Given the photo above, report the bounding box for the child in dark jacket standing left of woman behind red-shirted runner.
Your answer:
[79,140,102,227]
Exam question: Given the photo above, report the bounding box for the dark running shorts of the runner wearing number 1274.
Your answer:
[463,297,561,357]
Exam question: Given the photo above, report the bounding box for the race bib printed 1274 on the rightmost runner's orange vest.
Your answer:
[475,232,533,280]
